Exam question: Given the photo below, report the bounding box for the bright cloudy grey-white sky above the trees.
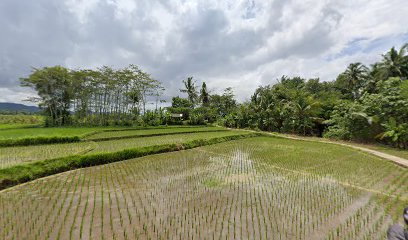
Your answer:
[0,0,408,105]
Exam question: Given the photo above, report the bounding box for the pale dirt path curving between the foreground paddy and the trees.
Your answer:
[234,129,408,168]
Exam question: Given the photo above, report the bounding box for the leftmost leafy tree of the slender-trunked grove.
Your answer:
[20,66,73,126]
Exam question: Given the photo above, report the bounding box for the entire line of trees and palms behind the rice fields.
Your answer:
[21,44,408,148]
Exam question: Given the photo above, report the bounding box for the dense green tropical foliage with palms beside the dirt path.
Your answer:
[225,44,408,148]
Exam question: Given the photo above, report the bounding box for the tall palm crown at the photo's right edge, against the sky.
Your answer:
[380,43,408,79]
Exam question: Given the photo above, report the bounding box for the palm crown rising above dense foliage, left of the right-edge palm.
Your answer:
[342,62,368,99]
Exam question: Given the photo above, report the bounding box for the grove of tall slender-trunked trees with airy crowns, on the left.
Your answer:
[20,65,164,126]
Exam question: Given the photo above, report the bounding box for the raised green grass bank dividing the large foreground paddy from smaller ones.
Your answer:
[0,133,260,190]
